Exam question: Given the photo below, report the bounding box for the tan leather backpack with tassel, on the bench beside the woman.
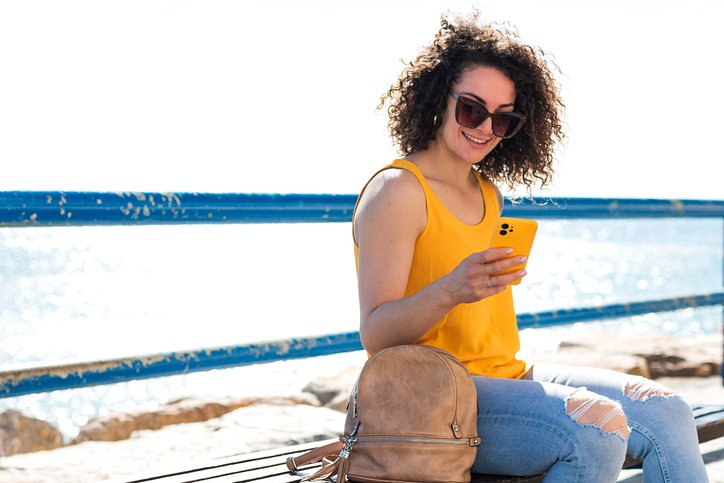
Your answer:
[287,345,480,483]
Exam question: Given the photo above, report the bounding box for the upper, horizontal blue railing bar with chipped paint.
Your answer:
[0,191,724,226]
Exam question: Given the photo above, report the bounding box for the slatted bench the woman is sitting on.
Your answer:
[124,406,724,483]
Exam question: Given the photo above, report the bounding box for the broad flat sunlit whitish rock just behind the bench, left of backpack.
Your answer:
[0,398,344,483]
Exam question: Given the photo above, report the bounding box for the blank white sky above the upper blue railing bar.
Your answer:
[0,0,724,199]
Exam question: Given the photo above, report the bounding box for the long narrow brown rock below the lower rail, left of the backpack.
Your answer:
[70,395,318,444]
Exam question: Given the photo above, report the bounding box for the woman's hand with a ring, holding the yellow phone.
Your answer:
[440,248,527,305]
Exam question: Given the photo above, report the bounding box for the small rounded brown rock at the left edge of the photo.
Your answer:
[0,409,63,456]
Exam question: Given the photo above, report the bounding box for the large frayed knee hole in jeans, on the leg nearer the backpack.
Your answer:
[566,388,630,441]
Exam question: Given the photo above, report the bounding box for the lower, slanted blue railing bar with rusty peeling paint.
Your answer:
[0,292,724,397]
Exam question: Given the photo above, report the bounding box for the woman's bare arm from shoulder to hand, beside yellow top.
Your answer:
[354,169,522,353]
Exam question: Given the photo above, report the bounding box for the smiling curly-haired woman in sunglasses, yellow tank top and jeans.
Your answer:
[353,15,707,483]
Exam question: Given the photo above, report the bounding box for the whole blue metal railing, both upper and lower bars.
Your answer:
[0,191,724,397]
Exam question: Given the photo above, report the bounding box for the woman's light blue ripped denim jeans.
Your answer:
[473,363,708,483]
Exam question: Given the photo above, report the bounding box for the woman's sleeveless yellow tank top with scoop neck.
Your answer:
[354,159,529,379]
